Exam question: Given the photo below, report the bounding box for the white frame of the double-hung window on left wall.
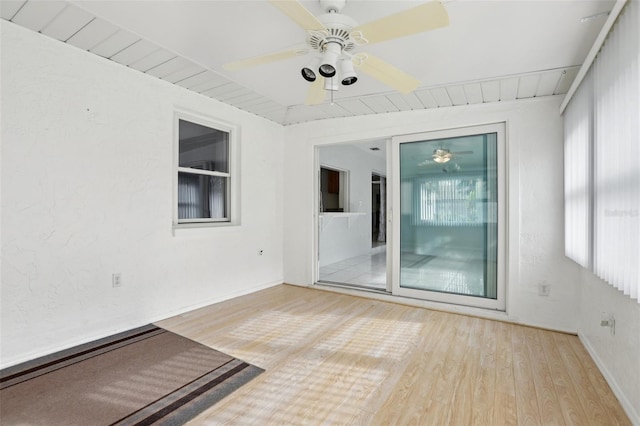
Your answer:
[172,110,240,229]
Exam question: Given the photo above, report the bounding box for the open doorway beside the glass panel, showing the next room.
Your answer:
[317,141,388,292]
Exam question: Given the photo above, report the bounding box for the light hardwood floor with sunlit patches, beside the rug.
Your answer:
[158,285,630,426]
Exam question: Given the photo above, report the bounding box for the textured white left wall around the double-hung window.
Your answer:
[1,20,283,366]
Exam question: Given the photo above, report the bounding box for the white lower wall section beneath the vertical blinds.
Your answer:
[578,269,640,425]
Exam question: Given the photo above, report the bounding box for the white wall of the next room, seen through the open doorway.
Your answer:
[318,145,386,266]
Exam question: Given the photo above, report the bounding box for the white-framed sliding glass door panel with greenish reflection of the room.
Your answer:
[394,126,504,309]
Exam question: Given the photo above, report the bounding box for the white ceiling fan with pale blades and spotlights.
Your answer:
[224,0,449,105]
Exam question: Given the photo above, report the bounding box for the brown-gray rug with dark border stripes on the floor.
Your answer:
[0,325,264,426]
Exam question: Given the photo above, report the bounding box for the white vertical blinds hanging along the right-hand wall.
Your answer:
[565,1,640,303]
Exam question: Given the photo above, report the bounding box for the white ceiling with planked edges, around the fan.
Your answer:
[0,0,615,124]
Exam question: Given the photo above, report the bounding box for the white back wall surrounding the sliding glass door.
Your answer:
[284,97,578,332]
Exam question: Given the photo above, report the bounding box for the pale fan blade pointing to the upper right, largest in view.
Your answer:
[354,1,449,44]
